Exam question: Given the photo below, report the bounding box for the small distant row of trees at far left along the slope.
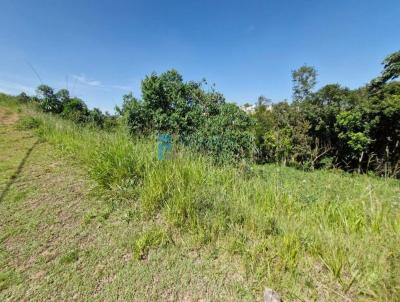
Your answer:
[18,85,117,129]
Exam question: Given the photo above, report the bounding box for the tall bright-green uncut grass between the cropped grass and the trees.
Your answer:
[34,110,400,301]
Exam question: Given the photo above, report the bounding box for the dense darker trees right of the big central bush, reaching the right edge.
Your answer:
[254,52,400,177]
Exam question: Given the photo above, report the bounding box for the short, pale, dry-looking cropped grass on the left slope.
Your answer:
[0,98,247,301]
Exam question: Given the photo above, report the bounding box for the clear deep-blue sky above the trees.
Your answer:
[0,0,400,111]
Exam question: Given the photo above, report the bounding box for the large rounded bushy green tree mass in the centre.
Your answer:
[125,70,254,162]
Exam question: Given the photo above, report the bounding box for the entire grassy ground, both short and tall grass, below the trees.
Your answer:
[0,96,400,301]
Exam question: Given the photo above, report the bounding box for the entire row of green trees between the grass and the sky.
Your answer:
[20,51,400,177]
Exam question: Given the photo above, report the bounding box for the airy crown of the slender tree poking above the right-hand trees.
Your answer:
[292,65,317,102]
